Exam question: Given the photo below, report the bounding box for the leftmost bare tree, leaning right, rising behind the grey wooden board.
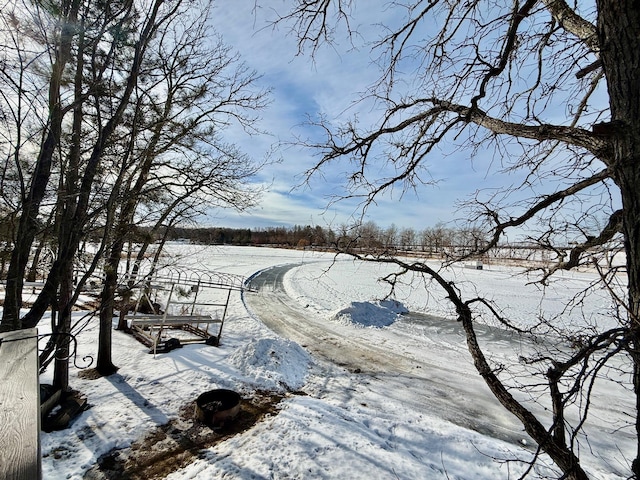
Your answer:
[2,2,73,328]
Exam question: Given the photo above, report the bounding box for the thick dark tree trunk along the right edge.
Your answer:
[597,0,640,478]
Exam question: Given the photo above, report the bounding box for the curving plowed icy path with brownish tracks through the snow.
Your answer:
[245,265,526,443]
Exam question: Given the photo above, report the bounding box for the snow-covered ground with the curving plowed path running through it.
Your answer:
[41,245,635,480]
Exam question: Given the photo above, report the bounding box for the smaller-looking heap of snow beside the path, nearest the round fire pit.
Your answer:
[229,338,311,391]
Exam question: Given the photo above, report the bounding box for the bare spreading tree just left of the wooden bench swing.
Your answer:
[90,8,266,374]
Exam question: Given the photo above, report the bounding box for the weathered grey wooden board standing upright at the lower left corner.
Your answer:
[0,328,41,480]
